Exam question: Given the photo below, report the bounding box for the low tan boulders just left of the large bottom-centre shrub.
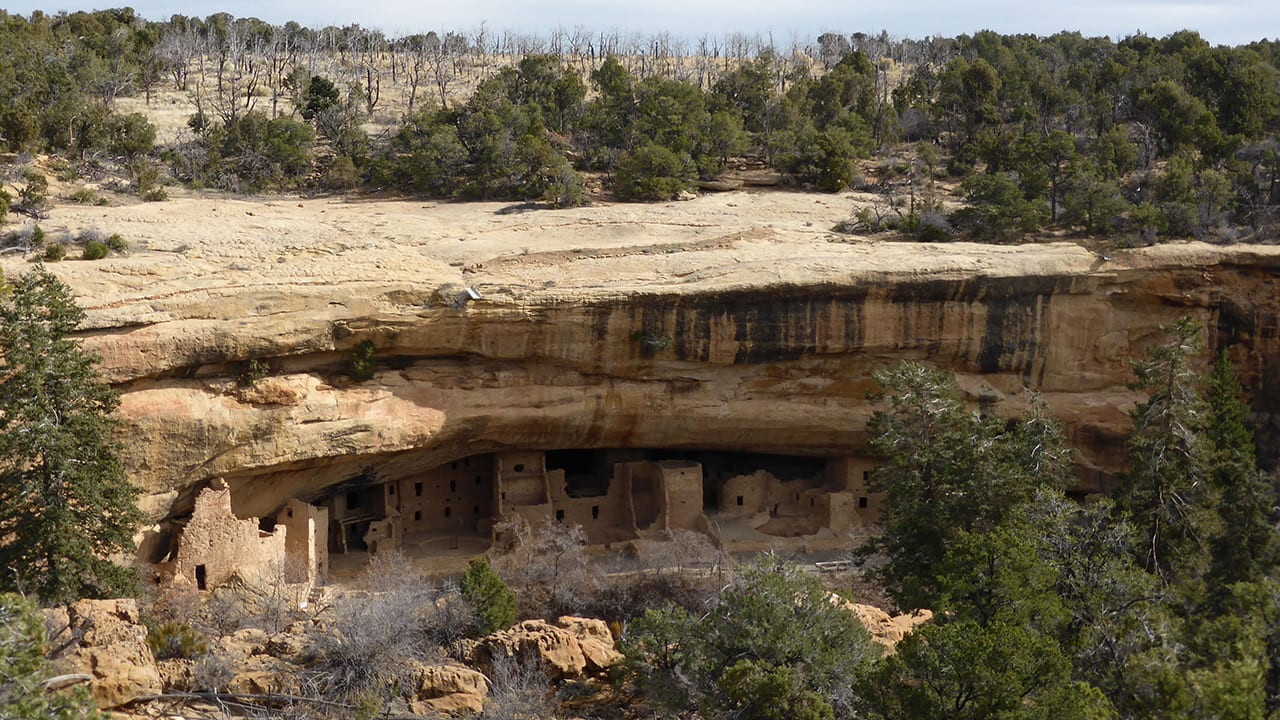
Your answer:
[471,616,621,679]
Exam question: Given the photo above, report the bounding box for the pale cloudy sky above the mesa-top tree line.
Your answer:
[3,0,1280,46]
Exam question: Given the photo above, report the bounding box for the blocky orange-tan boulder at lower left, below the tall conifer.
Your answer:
[51,600,161,708]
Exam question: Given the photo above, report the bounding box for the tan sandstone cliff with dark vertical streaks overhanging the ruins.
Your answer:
[3,192,1280,518]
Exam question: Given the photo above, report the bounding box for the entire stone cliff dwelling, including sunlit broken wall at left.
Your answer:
[142,450,881,591]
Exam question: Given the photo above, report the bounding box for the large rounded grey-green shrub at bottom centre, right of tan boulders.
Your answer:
[622,557,879,719]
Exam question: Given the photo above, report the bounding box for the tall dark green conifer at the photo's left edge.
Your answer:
[0,266,142,602]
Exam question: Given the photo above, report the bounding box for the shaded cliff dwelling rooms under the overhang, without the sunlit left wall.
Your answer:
[307,450,881,563]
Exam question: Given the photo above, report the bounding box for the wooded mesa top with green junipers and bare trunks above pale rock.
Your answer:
[0,9,1280,243]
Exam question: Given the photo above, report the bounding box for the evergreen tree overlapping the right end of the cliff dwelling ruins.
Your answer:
[865,363,1069,607]
